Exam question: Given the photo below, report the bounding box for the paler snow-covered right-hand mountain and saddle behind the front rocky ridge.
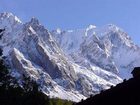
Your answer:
[52,24,140,78]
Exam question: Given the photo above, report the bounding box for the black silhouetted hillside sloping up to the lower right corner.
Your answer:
[76,67,140,105]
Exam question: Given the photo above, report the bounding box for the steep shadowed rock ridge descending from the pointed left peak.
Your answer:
[8,21,77,88]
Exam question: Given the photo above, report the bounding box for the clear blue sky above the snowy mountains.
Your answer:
[0,0,140,45]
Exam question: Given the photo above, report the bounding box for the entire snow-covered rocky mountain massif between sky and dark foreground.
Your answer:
[0,13,140,102]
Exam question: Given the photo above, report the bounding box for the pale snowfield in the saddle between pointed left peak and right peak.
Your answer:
[52,25,96,53]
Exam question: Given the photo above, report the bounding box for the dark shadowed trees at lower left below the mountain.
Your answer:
[0,49,73,105]
